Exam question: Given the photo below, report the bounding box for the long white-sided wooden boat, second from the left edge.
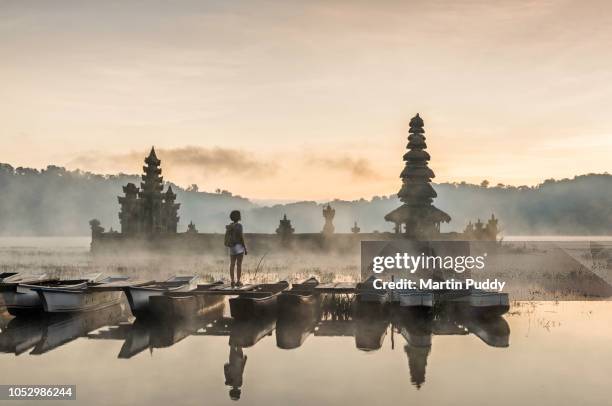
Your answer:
[30,277,149,313]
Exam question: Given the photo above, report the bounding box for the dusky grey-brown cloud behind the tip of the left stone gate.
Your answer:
[68,146,277,175]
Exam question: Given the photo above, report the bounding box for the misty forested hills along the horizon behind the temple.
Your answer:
[0,164,612,236]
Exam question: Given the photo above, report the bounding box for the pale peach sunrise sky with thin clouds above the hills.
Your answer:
[0,0,612,200]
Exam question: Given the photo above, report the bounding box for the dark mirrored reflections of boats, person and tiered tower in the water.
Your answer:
[0,295,510,400]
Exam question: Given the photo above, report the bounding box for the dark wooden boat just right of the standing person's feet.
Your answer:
[229,281,289,320]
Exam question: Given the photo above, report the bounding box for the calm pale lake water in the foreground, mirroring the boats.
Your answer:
[0,236,612,405]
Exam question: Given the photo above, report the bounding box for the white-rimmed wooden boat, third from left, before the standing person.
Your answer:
[125,275,199,318]
